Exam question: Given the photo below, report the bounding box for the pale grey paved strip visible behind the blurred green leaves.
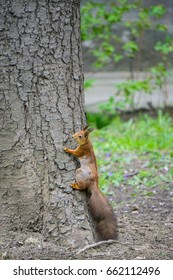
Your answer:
[85,72,173,111]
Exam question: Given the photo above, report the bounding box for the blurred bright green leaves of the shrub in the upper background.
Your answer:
[81,0,173,108]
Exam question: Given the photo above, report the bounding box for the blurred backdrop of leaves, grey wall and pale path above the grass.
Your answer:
[81,0,173,114]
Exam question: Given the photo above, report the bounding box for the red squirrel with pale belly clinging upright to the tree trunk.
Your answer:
[64,126,118,240]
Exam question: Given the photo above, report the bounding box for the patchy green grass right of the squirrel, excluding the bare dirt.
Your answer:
[91,111,173,195]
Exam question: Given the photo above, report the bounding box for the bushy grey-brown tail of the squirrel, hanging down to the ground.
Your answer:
[89,188,118,240]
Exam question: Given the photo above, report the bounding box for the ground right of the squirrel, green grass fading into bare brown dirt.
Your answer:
[84,111,173,259]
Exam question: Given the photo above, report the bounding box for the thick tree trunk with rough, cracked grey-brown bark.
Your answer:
[0,0,93,247]
